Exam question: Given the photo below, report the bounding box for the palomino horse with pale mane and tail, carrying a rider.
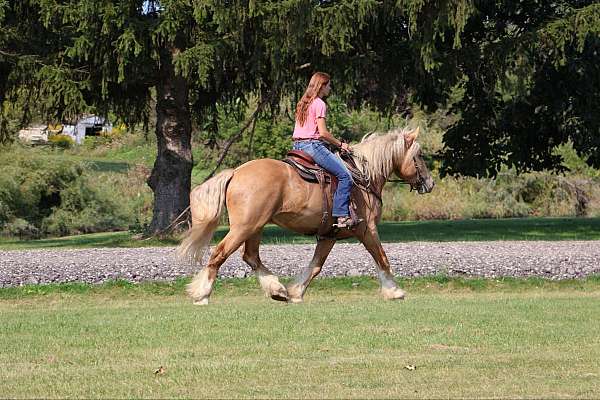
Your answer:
[177,128,434,304]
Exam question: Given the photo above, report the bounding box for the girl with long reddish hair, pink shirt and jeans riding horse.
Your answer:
[293,72,352,229]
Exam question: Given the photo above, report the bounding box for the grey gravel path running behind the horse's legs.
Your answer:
[0,241,600,287]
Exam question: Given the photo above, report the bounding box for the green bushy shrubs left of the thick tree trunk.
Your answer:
[0,151,139,237]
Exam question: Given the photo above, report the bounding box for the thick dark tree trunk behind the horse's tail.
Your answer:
[148,51,193,234]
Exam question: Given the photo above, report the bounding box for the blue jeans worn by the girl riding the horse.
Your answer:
[294,140,353,217]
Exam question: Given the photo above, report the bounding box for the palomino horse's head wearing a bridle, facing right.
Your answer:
[395,127,435,194]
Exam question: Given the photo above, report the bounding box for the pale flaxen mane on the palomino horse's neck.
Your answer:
[352,128,410,180]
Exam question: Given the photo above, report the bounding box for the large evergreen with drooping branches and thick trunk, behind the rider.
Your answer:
[0,0,426,232]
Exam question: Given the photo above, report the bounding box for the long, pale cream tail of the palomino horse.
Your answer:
[176,169,234,263]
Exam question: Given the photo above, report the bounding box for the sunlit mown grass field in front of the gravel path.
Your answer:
[0,277,600,398]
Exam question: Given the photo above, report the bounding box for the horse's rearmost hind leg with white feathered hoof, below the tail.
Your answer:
[187,228,249,305]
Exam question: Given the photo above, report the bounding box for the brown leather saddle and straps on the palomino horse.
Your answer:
[282,150,365,239]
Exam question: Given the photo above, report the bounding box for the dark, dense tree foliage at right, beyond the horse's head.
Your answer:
[404,0,600,176]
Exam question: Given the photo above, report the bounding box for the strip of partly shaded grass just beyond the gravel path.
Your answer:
[0,218,600,250]
